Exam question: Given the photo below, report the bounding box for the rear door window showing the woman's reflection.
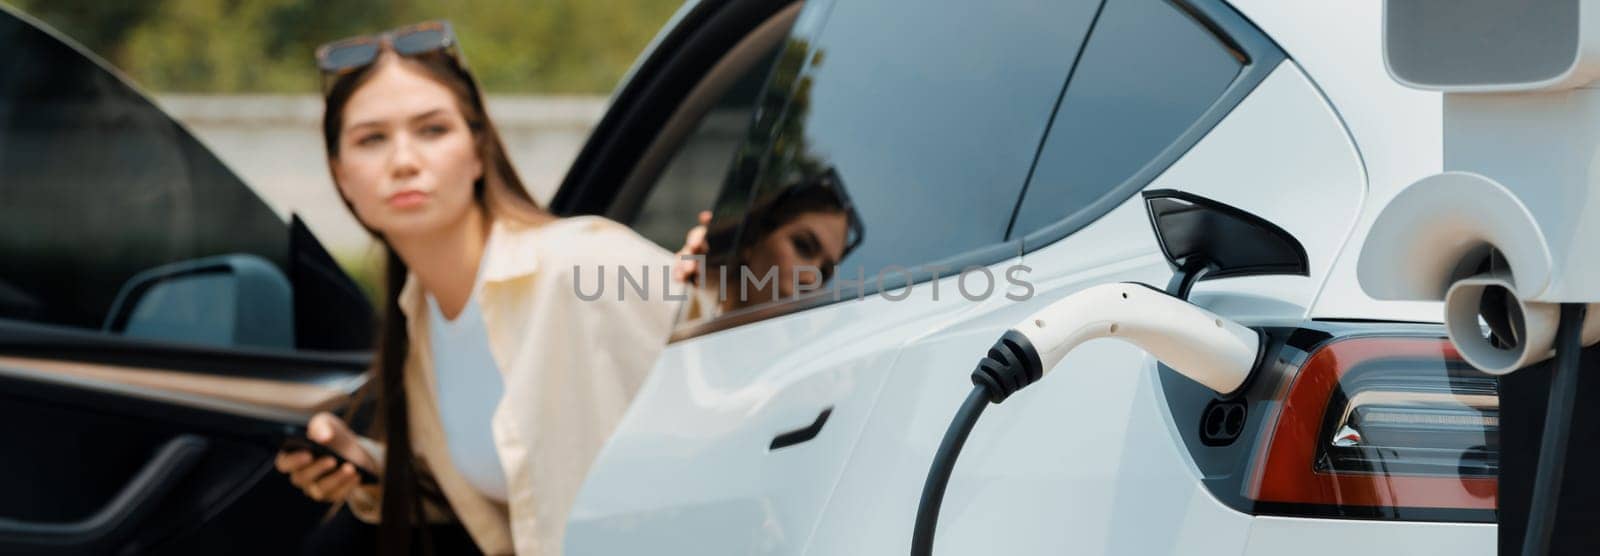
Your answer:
[691,2,1098,330]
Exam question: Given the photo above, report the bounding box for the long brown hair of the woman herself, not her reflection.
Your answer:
[322,53,554,554]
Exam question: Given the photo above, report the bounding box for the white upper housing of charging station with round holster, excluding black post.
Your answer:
[1357,0,1600,374]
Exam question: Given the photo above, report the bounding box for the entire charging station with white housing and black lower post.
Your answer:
[1358,0,1600,554]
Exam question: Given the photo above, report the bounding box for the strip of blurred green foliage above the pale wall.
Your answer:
[0,0,682,94]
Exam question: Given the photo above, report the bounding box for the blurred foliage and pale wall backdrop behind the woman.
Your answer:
[5,0,694,300]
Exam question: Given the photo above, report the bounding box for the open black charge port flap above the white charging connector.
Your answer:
[1144,189,1310,299]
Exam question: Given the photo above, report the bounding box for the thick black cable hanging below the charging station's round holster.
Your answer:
[1522,304,1587,556]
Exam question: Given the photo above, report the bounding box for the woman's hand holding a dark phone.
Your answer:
[274,412,378,502]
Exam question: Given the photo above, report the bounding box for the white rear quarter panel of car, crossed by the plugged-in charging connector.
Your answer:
[806,62,1365,554]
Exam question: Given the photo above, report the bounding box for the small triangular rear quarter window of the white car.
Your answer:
[1013,0,1243,236]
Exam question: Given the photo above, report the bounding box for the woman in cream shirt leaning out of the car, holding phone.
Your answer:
[277,22,677,554]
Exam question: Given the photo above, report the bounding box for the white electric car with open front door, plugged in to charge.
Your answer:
[0,0,1542,556]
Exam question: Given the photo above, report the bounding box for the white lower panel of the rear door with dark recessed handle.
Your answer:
[566,262,1011,554]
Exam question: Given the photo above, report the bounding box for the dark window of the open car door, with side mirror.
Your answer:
[0,11,370,350]
